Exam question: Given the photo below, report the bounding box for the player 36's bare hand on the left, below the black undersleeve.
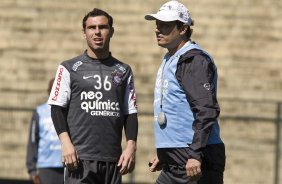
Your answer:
[59,132,78,170]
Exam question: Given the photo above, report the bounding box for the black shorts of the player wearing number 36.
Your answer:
[65,160,121,184]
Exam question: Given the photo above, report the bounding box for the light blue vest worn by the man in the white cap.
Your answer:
[154,42,222,148]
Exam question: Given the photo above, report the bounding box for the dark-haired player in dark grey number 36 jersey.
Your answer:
[48,8,138,184]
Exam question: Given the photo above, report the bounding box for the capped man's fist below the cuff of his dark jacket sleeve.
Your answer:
[186,158,202,180]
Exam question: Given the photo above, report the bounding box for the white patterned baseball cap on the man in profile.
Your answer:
[145,1,193,26]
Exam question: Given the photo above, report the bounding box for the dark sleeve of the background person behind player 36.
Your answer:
[26,110,39,175]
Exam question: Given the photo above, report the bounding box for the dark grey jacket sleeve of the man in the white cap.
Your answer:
[176,54,220,161]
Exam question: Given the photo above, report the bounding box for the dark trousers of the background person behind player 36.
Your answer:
[38,168,64,184]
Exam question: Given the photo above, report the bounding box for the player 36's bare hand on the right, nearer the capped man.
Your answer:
[118,140,136,175]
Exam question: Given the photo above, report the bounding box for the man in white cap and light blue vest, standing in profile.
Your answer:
[145,1,225,184]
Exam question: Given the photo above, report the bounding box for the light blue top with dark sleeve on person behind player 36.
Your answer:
[26,103,63,174]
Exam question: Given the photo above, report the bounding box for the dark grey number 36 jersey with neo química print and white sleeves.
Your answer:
[48,52,137,161]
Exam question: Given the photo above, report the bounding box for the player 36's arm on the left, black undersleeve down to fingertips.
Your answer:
[51,105,78,170]
